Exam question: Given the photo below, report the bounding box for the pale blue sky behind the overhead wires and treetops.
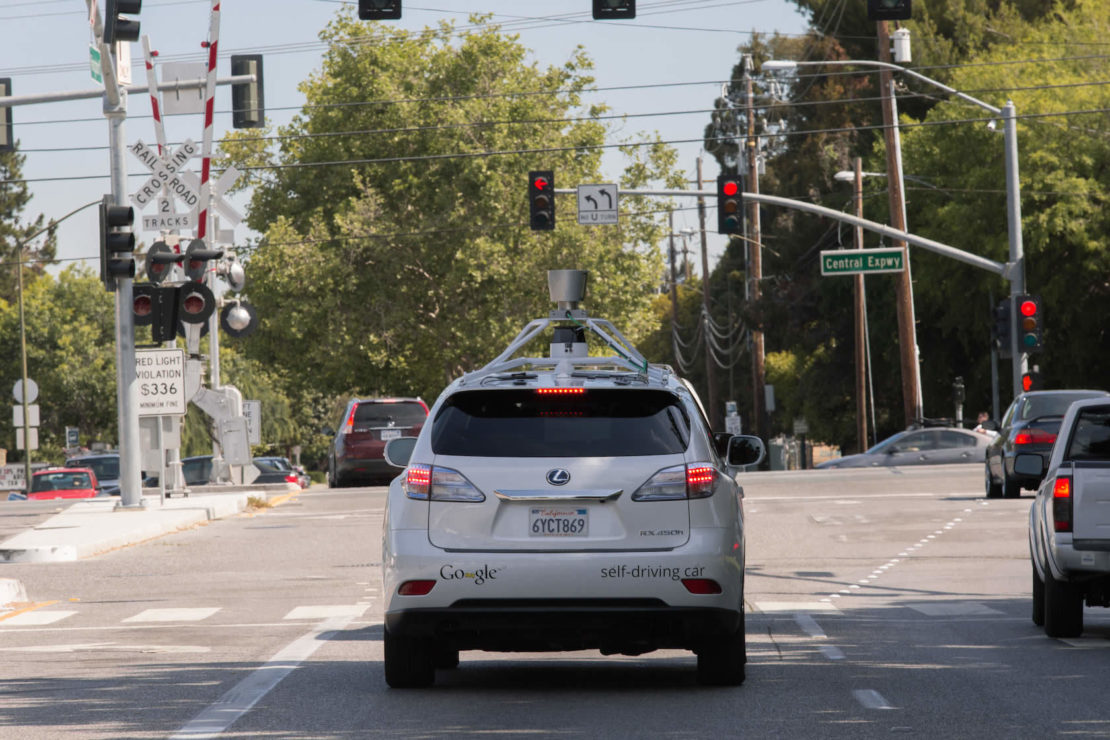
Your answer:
[0,0,806,277]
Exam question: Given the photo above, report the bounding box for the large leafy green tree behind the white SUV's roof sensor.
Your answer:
[224,11,680,401]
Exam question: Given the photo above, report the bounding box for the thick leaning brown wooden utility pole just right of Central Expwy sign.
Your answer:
[878,21,925,426]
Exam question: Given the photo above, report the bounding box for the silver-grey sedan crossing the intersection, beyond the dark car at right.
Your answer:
[814,427,991,469]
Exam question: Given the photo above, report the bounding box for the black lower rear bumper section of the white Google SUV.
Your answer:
[385,599,743,655]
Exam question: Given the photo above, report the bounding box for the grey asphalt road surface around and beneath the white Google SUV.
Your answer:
[0,466,1110,739]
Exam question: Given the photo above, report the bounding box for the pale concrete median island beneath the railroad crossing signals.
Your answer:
[0,486,301,614]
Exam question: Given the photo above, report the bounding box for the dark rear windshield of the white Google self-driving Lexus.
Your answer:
[432,388,689,457]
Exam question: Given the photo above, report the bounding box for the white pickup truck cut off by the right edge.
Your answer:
[1015,398,1110,637]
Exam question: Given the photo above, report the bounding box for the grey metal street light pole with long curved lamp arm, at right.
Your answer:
[763,54,1029,396]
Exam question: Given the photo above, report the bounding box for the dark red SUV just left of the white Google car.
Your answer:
[327,398,427,488]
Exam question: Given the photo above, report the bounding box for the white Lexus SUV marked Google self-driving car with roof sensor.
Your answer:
[382,271,764,688]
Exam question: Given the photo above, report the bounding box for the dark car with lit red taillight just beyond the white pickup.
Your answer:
[983,391,1110,498]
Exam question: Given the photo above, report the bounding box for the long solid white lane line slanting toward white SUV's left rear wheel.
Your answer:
[171,616,354,740]
